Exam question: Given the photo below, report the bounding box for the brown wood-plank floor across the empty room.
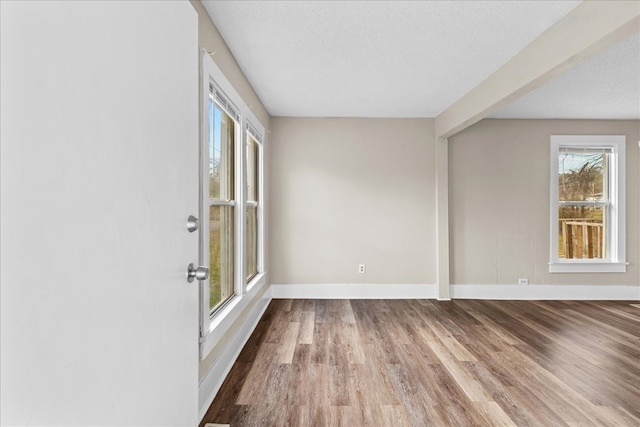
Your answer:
[202,300,640,426]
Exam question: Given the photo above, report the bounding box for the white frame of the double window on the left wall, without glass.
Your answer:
[198,49,266,360]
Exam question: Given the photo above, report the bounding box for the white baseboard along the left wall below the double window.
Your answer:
[198,289,271,420]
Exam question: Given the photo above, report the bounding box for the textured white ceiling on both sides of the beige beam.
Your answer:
[203,1,640,118]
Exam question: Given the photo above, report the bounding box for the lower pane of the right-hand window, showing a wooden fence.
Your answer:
[558,206,606,259]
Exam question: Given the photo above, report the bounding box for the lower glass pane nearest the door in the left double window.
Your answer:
[209,206,234,311]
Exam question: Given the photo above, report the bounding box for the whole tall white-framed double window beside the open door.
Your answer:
[199,51,266,359]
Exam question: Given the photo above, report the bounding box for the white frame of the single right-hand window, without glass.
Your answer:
[549,135,628,273]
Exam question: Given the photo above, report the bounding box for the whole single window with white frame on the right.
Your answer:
[549,135,626,273]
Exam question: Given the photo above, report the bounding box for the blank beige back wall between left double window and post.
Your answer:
[268,118,435,284]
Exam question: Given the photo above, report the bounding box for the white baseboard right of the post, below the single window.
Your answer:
[450,285,640,301]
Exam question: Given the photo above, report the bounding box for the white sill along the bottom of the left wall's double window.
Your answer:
[200,273,266,360]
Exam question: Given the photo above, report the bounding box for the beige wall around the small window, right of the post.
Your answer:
[449,120,640,285]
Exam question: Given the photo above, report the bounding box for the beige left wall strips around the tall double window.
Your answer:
[191,1,271,380]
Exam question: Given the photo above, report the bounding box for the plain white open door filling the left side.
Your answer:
[0,1,198,426]
